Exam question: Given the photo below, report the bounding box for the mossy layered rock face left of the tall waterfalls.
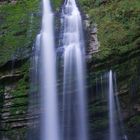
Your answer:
[0,0,40,140]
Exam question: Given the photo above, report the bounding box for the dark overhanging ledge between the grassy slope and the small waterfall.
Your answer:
[87,44,140,71]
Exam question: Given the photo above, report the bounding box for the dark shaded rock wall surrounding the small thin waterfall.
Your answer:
[88,56,140,140]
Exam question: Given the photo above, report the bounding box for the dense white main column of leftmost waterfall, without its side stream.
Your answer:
[39,0,59,140]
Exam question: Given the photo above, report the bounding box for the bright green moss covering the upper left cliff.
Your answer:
[0,0,39,64]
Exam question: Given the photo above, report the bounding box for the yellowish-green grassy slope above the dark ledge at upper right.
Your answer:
[79,0,140,60]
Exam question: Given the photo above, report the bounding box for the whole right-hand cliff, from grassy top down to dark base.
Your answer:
[80,0,140,140]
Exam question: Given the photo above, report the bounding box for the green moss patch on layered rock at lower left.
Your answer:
[10,61,30,115]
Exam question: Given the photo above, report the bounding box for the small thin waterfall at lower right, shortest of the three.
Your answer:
[108,70,128,140]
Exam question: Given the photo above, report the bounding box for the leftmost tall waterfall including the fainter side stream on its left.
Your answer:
[29,0,60,140]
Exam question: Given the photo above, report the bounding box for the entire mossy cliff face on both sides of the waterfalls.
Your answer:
[0,0,140,140]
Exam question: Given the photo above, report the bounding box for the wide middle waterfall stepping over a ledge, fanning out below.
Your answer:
[61,0,88,140]
